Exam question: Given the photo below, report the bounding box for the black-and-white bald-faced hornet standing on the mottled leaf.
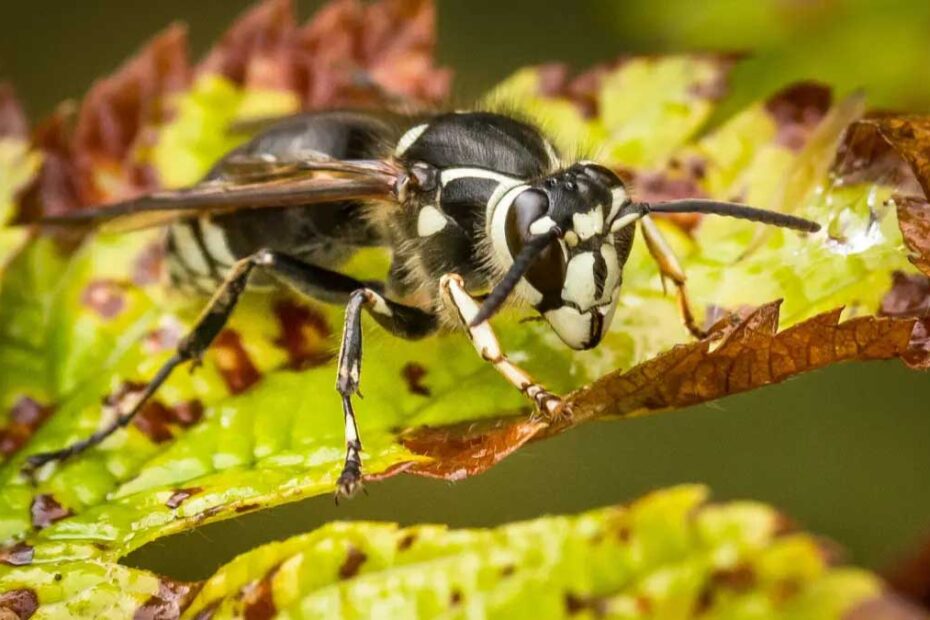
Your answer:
[26,112,819,495]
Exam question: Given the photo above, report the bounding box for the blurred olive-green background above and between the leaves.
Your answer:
[0,0,930,578]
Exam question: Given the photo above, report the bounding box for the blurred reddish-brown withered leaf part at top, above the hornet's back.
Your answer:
[197,0,451,109]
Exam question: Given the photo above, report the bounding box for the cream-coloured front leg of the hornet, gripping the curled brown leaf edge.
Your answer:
[439,273,570,421]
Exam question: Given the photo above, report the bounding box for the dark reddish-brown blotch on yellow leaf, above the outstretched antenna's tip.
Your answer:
[765,82,832,152]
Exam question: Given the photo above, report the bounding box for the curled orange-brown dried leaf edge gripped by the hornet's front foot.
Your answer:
[404,302,930,480]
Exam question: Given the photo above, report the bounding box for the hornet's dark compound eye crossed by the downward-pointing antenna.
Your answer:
[506,189,566,304]
